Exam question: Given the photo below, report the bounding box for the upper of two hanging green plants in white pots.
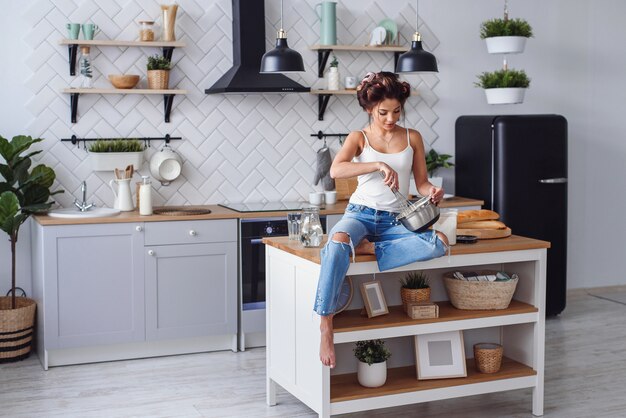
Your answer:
[480,15,533,54]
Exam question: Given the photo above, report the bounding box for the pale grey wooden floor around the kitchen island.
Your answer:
[0,287,626,418]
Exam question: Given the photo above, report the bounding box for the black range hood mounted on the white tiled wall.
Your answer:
[204,0,311,94]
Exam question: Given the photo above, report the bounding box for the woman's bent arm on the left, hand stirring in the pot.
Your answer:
[330,131,398,188]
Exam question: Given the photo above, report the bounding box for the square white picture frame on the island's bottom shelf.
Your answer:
[415,331,467,380]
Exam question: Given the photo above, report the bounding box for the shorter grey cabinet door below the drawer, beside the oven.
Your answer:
[145,242,237,340]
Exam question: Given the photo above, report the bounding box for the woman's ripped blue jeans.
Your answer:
[313,203,446,316]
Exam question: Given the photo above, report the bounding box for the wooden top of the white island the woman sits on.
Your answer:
[263,235,550,264]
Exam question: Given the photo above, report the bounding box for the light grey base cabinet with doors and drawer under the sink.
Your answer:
[32,219,237,369]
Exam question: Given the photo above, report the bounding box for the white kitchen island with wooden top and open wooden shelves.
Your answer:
[265,236,550,417]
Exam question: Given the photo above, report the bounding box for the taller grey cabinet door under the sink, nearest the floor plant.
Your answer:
[43,223,145,348]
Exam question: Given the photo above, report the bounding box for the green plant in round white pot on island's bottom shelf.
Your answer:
[354,340,391,388]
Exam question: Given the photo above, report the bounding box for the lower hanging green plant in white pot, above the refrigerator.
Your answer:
[474,69,530,104]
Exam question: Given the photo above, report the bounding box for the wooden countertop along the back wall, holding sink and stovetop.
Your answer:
[34,196,484,226]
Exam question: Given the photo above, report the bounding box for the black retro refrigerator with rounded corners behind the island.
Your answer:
[455,115,567,316]
